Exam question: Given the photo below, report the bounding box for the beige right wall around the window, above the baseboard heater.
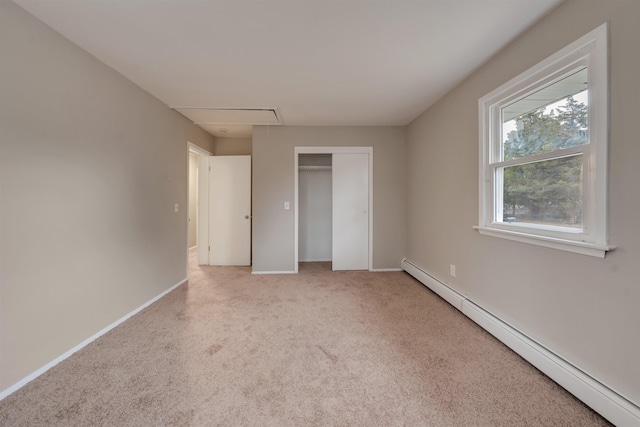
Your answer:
[407,0,640,404]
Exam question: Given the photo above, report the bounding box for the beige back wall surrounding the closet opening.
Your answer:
[252,126,406,271]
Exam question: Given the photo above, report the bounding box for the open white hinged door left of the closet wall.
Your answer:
[209,156,251,265]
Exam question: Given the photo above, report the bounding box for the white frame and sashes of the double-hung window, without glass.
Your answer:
[474,23,615,258]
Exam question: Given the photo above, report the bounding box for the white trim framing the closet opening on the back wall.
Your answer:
[293,146,373,273]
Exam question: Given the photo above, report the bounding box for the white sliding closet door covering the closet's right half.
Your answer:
[332,153,369,270]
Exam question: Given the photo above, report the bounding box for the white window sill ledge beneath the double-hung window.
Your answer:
[473,225,615,258]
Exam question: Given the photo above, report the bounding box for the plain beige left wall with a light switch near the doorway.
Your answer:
[0,1,213,390]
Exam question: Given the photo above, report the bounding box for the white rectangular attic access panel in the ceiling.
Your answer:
[174,107,282,125]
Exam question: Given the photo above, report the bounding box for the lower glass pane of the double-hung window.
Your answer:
[498,154,583,228]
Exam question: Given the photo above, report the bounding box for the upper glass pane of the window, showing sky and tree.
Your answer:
[502,68,589,160]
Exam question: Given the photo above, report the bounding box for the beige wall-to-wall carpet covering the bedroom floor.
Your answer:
[0,249,607,426]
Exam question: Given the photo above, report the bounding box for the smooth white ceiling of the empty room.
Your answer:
[14,0,561,137]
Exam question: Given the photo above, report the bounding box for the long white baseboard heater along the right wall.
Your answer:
[402,258,640,426]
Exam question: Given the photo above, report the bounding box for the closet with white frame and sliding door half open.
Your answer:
[294,147,373,273]
